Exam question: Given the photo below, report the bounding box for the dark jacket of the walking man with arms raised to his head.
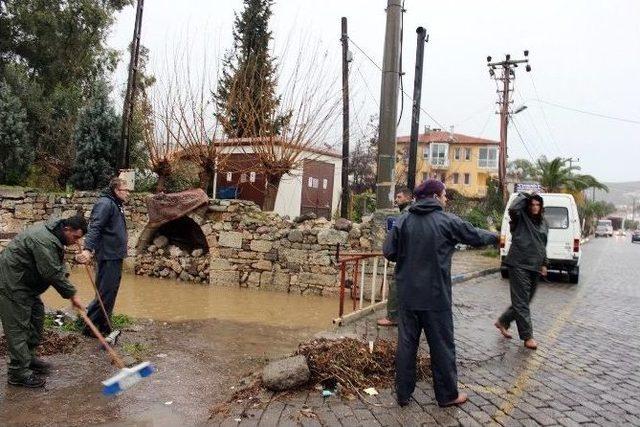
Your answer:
[504,193,549,271]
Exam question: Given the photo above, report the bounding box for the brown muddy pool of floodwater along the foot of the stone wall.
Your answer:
[43,267,348,329]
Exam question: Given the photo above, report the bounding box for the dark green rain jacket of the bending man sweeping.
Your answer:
[0,220,76,303]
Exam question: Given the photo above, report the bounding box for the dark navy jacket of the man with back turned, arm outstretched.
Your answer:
[383,199,498,310]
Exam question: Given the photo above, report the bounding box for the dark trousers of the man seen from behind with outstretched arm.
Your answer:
[396,308,458,405]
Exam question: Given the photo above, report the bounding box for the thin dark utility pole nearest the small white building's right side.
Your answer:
[340,17,351,218]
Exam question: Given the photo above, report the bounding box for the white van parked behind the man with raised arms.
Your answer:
[500,193,582,283]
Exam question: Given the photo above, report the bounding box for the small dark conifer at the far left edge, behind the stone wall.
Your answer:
[0,81,34,184]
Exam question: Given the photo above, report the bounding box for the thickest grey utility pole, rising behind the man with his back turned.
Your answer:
[376,0,403,209]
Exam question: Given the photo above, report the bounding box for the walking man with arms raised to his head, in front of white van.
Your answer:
[495,193,549,350]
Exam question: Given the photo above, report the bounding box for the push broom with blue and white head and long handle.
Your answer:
[76,309,156,396]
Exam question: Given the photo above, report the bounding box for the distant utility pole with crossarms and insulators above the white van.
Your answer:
[487,50,531,203]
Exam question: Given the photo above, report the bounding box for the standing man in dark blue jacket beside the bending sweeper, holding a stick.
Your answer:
[78,178,129,336]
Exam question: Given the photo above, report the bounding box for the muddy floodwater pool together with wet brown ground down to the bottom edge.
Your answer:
[0,268,350,426]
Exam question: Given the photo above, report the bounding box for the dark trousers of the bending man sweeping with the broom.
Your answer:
[0,293,44,380]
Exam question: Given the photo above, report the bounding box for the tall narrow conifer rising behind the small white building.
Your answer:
[214,0,287,138]
